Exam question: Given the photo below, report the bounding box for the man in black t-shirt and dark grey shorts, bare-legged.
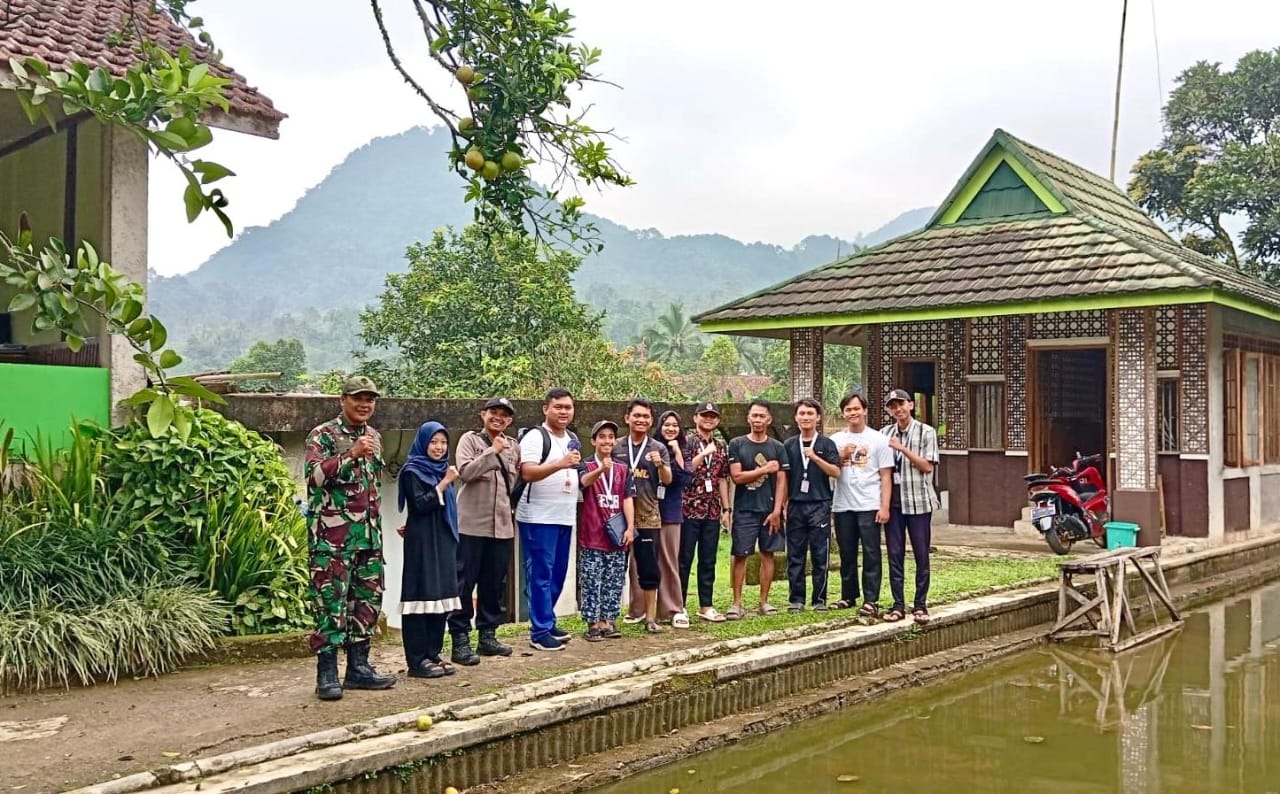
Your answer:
[724,400,787,620]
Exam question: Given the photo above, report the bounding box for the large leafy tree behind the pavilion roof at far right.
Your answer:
[1129,49,1280,283]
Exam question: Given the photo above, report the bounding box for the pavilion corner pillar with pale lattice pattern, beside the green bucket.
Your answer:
[1112,309,1160,546]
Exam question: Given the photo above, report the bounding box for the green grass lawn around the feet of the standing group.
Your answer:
[499,538,1062,640]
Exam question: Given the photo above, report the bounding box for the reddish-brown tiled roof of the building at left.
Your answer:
[0,0,285,137]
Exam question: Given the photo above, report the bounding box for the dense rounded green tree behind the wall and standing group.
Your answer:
[360,223,660,397]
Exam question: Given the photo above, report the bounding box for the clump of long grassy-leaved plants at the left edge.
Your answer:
[0,426,228,689]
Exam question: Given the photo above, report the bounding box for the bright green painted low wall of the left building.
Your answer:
[0,364,111,455]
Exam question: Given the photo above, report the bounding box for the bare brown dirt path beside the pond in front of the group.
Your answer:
[0,526,1203,794]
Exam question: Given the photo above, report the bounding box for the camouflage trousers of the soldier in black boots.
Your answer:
[310,542,383,653]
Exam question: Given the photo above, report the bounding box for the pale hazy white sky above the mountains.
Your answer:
[150,0,1280,274]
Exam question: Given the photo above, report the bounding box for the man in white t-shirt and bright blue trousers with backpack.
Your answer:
[516,389,582,651]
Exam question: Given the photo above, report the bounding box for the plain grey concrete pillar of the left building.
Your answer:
[99,127,148,423]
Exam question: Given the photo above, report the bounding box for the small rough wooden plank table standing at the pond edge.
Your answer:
[1048,546,1183,652]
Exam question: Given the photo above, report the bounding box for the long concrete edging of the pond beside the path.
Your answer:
[76,537,1280,794]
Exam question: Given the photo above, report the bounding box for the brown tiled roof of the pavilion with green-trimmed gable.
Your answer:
[694,131,1280,332]
